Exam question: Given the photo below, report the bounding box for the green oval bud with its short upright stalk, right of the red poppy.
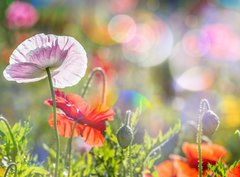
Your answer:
[117,111,133,148]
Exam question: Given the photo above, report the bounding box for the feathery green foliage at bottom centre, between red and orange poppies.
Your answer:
[40,112,180,177]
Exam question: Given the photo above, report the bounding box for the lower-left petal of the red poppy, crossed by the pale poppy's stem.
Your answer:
[48,113,83,138]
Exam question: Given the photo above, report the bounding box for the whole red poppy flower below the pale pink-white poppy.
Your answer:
[44,90,114,146]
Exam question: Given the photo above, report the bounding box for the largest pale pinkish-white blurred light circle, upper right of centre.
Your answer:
[122,16,173,67]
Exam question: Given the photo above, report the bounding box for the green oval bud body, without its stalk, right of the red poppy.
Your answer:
[117,125,133,148]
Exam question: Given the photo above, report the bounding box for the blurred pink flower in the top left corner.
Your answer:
[6,1,38,29]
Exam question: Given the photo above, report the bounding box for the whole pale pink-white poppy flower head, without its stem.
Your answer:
[3,34,87,88]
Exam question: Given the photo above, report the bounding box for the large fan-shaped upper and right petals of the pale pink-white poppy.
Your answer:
[5,34,87,88]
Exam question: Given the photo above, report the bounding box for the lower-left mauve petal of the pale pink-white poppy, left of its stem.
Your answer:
[3,62,47,83]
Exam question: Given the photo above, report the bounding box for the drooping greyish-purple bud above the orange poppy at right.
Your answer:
[202,110,220,136]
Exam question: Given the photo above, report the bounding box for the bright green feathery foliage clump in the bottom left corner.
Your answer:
[0,117,48,177]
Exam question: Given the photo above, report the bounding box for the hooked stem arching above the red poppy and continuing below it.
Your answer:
[67,67,107,177]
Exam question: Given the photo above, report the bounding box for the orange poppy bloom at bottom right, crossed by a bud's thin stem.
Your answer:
[155,143,228,177]
